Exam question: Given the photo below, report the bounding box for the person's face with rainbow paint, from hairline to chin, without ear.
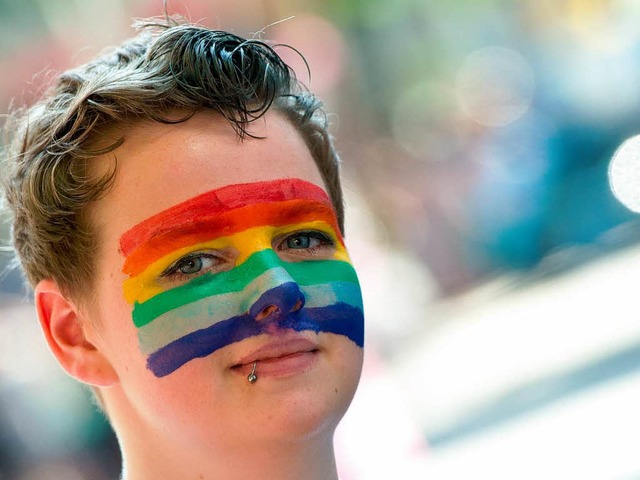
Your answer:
[85,112,363,449]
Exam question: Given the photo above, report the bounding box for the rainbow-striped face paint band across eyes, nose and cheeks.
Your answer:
[120,179,364,377]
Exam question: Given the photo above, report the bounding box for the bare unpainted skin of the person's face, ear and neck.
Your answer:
[36,112,363,480]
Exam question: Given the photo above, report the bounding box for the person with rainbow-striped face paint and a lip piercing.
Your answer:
[2,19,364,480]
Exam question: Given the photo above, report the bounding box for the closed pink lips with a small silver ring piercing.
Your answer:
[231,337,319,378]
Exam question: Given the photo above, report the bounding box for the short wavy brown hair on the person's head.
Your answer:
[1,19,344,300]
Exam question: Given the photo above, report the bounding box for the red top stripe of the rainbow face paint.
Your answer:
[120,178,337,256]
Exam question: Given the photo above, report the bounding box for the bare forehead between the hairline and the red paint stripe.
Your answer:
[93,112,324,238]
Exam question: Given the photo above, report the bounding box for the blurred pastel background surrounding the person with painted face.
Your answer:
[0,0,640,480]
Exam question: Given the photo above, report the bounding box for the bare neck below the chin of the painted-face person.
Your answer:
[111,392,338,480]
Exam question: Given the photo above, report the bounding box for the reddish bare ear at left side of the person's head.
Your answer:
[35,280,118,387]
